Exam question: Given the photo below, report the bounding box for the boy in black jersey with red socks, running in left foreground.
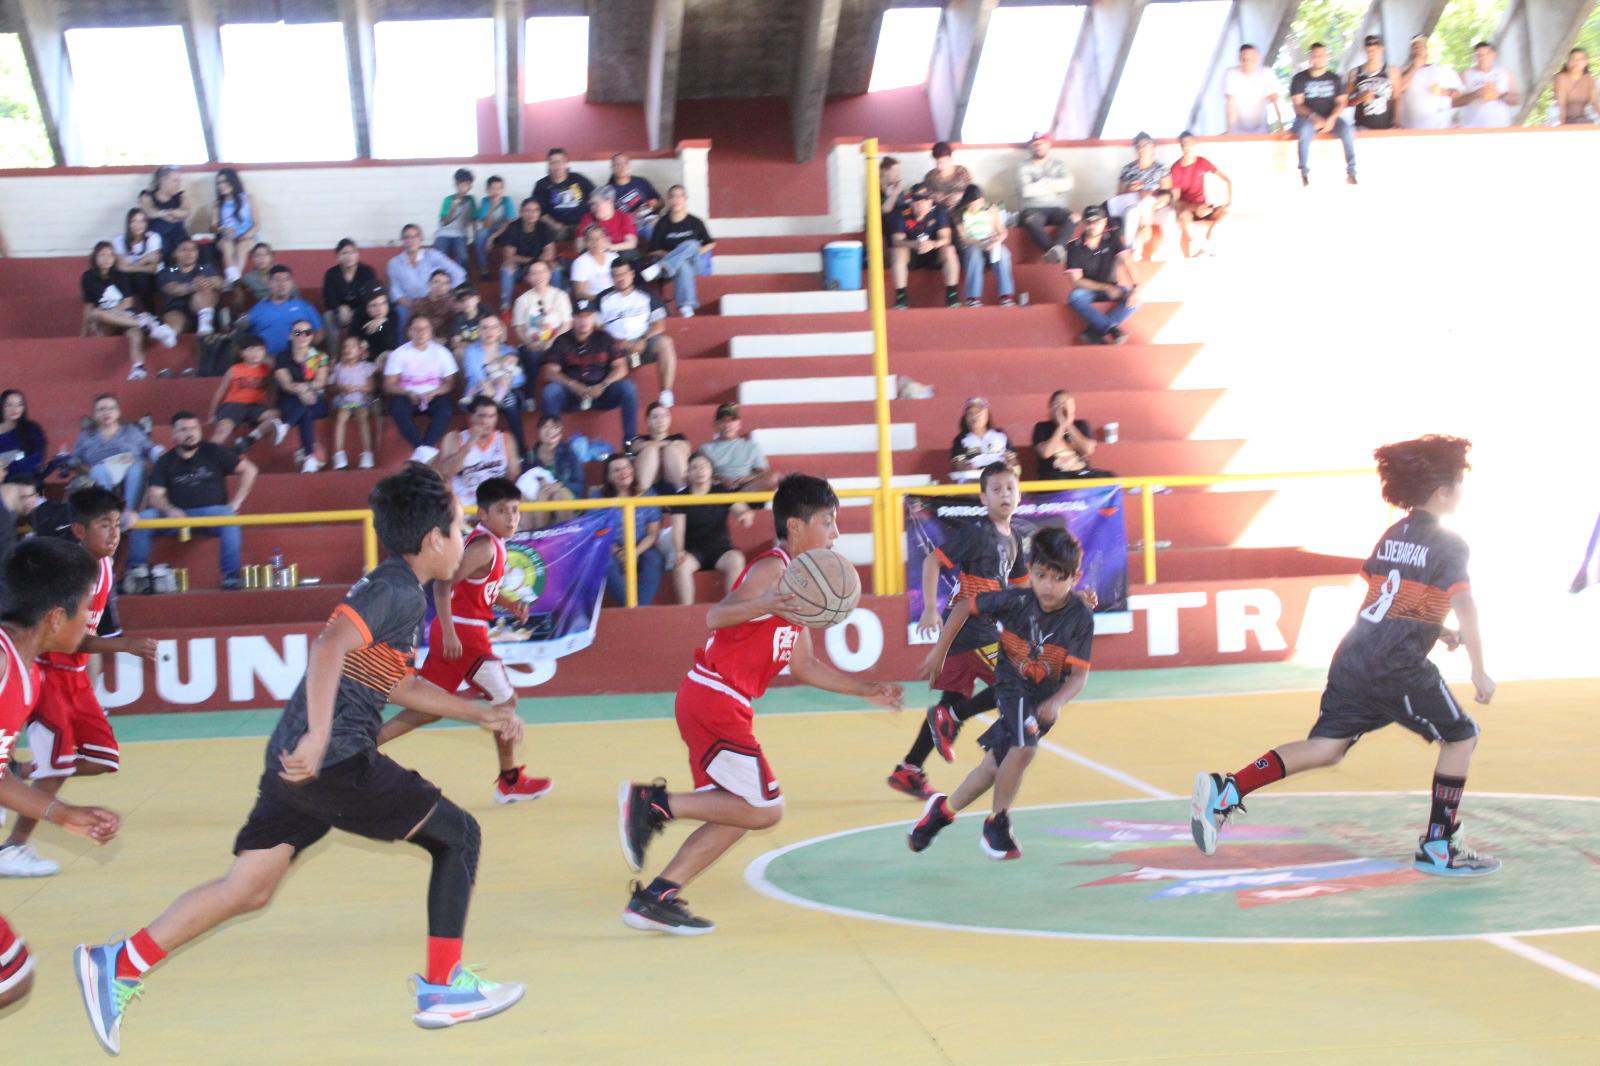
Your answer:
[74,463,523,1055]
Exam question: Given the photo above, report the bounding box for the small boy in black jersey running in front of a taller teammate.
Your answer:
[909,530,1094,860]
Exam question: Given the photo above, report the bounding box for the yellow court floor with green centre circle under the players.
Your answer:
[0,680,1600,1066]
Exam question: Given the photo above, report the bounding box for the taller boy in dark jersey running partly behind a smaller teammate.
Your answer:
[888,463,1032,799]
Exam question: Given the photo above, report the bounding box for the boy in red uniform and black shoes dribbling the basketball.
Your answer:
[618,474,904,936]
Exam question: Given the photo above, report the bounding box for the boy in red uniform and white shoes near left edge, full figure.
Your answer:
[0,485,155,877]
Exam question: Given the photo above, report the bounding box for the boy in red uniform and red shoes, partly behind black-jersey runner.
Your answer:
[378,477,550,804]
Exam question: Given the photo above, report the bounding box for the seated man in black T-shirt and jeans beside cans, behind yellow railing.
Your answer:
[128,408,259,589]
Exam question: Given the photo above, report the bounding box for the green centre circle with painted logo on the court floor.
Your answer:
[746,792,1600,941]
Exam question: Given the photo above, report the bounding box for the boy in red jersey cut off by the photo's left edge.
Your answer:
[0,536,118,1008]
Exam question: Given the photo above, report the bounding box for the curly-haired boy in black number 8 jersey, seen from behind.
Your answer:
[1189,437,1501,877]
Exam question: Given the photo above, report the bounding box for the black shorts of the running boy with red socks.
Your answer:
[234,751,440,855]
